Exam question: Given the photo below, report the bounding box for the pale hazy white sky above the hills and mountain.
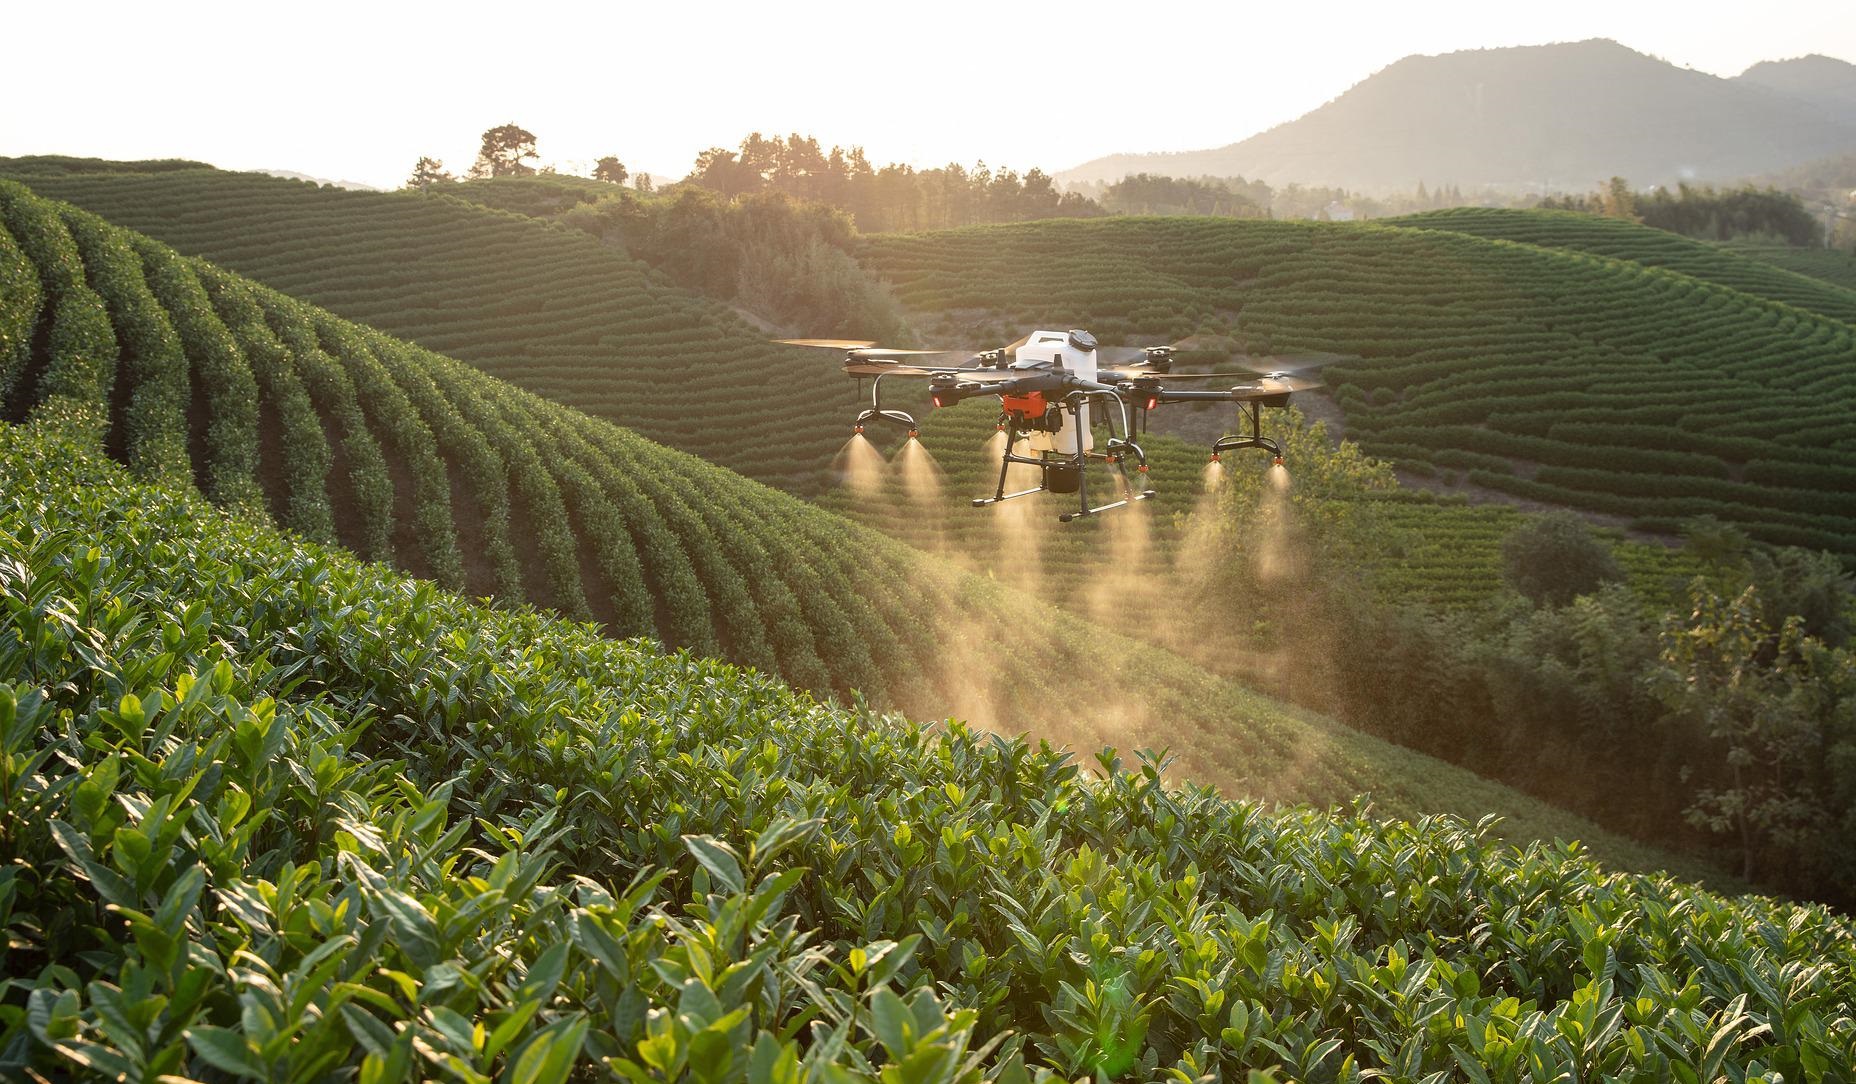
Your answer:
[0,0,1856,186]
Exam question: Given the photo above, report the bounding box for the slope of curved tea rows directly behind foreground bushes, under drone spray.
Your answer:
[0,182,1700,869]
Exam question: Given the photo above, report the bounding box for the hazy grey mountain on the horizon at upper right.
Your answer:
[1058,39,1856,193]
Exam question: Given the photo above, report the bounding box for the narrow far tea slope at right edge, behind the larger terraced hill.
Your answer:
[1381,208,1856,323]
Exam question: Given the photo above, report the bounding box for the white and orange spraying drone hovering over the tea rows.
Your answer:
[778,330,1314,523]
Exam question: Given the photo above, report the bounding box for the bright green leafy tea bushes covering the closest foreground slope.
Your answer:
[0,418,1856,1084]
